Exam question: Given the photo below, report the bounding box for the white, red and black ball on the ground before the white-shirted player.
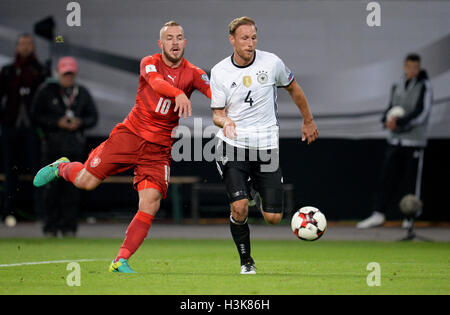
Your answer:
[291,207,327,241]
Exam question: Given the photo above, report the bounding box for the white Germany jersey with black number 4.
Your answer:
[210,50,294,150]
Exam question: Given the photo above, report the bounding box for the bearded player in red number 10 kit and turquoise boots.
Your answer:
[34,21,211,272]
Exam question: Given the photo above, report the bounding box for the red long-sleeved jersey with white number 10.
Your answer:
[119,54,211,146]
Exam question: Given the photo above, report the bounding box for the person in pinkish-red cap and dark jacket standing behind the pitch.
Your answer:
[33,57,97,236]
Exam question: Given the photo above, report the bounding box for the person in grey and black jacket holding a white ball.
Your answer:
[357,54,432,228]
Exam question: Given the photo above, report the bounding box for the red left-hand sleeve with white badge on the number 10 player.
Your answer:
[140,56,184,97]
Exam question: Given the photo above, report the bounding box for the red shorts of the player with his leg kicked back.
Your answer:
[84,124,172,198]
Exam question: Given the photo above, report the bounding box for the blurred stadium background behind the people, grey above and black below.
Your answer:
[0,0,450,227]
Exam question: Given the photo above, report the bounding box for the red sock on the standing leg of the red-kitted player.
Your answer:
[114,210,154,262]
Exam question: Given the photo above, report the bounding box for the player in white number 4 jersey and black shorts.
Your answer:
[210,17,318,274]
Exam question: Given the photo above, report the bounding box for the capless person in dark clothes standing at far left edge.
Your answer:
[0,34,45,223]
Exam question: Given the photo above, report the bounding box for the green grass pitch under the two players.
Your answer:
[0,239,450,295]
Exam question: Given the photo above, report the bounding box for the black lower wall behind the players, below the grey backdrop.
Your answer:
[73,138,450,221]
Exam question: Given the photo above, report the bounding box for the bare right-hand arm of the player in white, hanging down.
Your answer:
[285,79,319,144]
